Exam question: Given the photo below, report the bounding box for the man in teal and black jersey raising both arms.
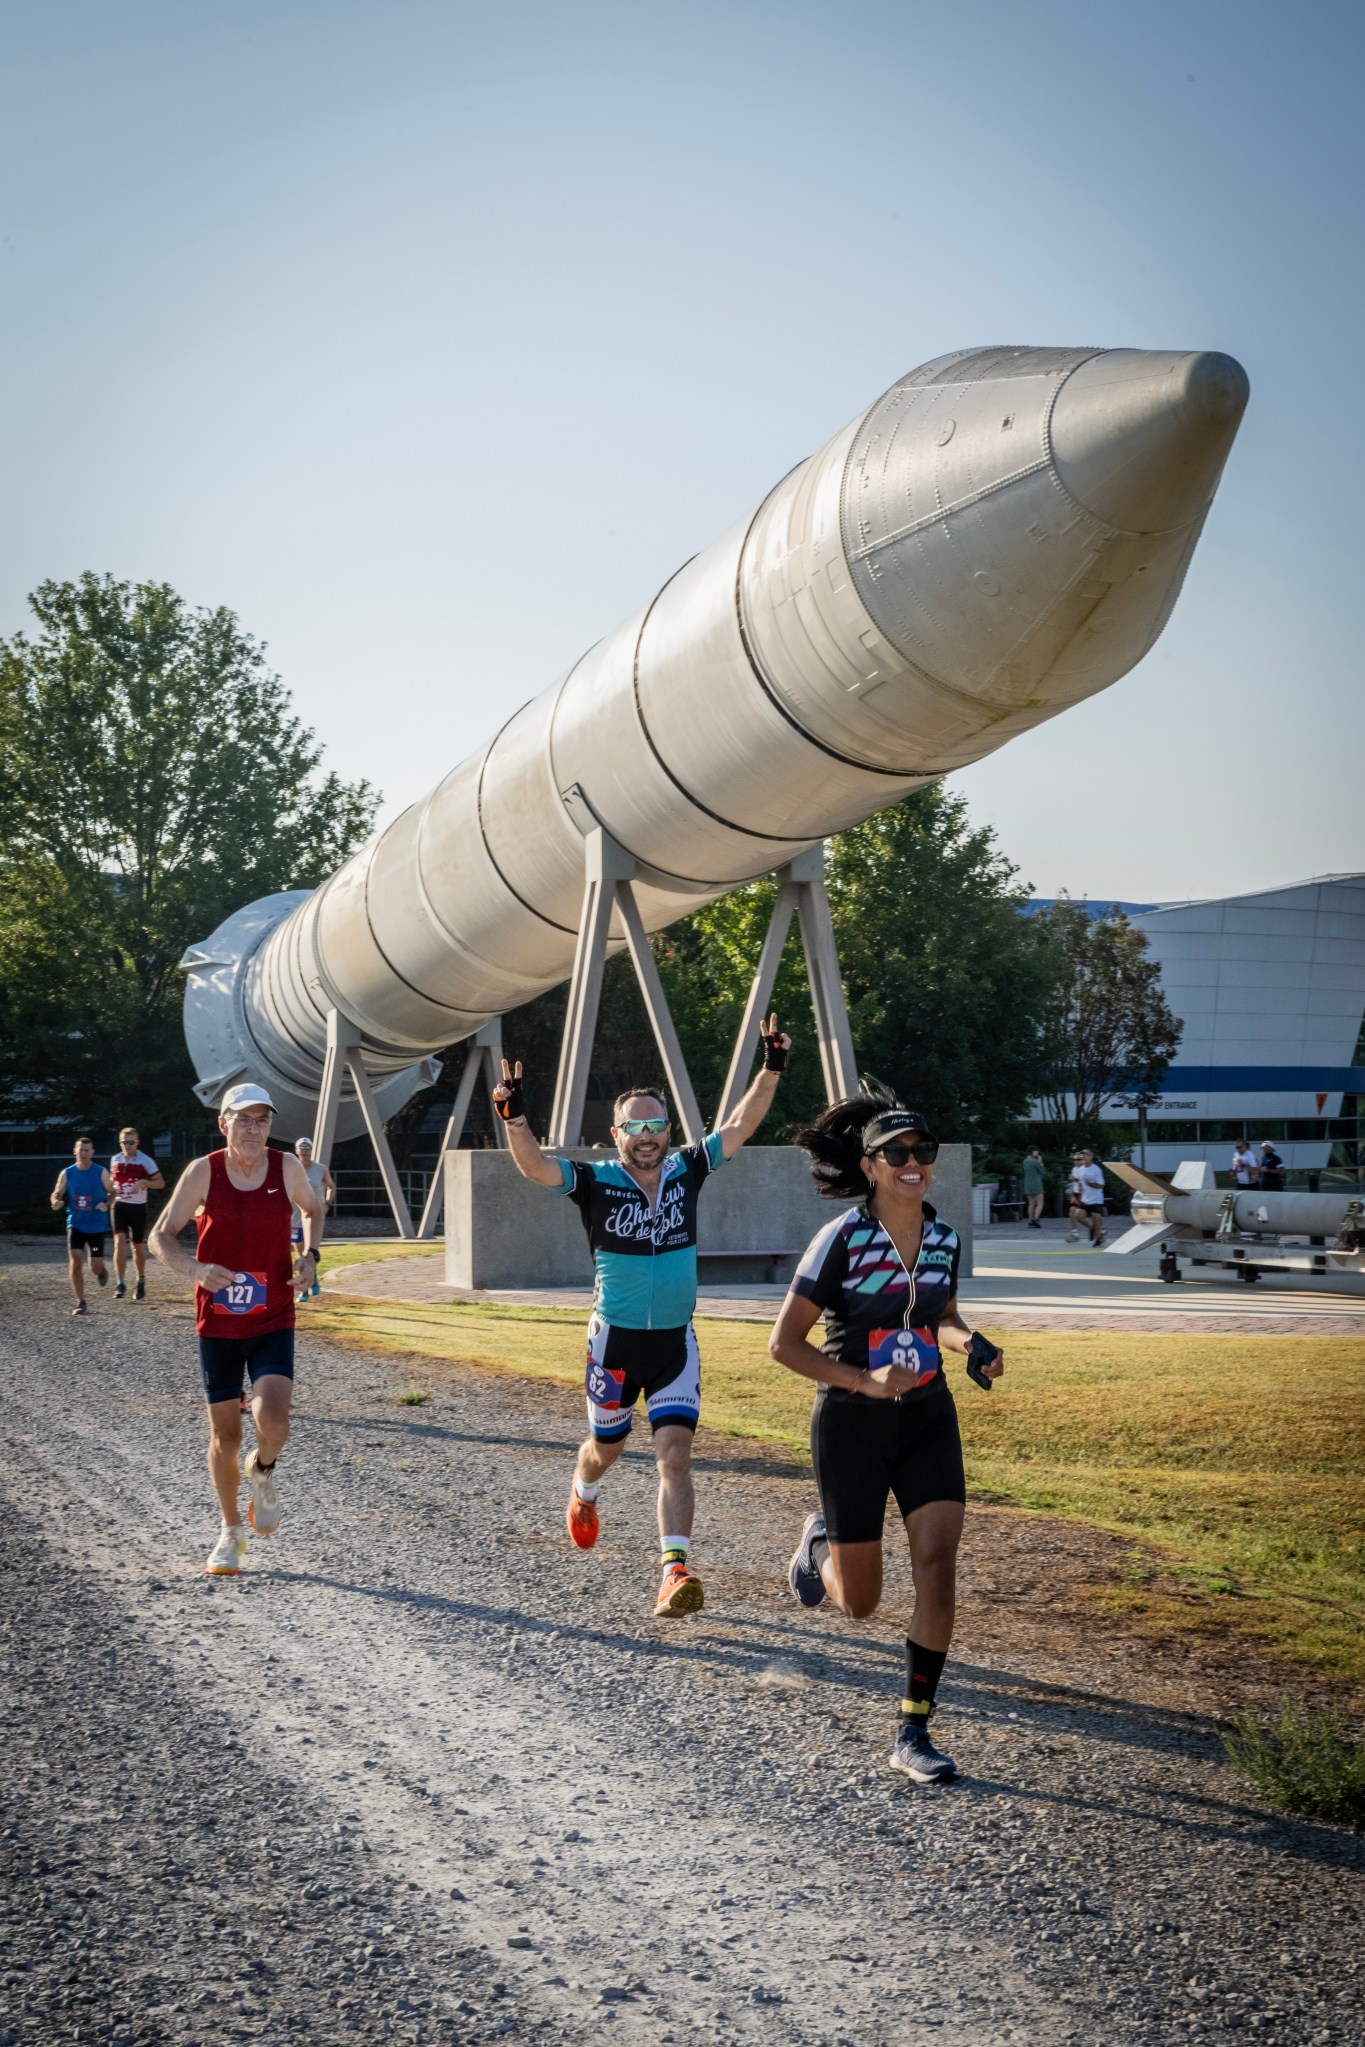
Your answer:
[493,1015,792,1613]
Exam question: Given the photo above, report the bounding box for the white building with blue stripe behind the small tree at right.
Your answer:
[1105,874,1365,1171]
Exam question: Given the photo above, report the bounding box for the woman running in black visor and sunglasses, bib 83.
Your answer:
[767,1079,1005,1783]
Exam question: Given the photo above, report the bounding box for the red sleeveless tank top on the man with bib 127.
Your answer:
[194,1150,295,1337]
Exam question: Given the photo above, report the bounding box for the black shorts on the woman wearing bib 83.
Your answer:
[810,1386,966,1541]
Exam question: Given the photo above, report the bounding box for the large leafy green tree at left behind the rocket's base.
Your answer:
[0,575,377,1130]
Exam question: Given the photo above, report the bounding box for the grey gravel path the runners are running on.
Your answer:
[0,1251,1365,2047]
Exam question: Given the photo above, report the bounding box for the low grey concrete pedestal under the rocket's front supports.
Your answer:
[446,1144,972,1290]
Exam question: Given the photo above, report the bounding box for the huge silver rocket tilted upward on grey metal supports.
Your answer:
[184,348,1246,1134]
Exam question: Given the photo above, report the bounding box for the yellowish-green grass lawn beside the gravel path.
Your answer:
[307,1245,1365,1685]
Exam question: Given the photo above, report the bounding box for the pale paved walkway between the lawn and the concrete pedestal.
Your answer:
[327,1224,1365,1337]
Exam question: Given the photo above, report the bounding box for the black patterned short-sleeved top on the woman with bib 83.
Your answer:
[792,1202,962,1400]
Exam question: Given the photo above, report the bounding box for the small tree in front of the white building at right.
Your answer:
[1033,897,1183,1146]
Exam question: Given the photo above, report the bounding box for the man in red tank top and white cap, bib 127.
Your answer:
[149,1083,323,1578]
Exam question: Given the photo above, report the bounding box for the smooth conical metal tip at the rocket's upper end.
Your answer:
[1050,348,1250,532]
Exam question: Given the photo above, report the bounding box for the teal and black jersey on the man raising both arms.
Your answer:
[559,1130,724,1329]
